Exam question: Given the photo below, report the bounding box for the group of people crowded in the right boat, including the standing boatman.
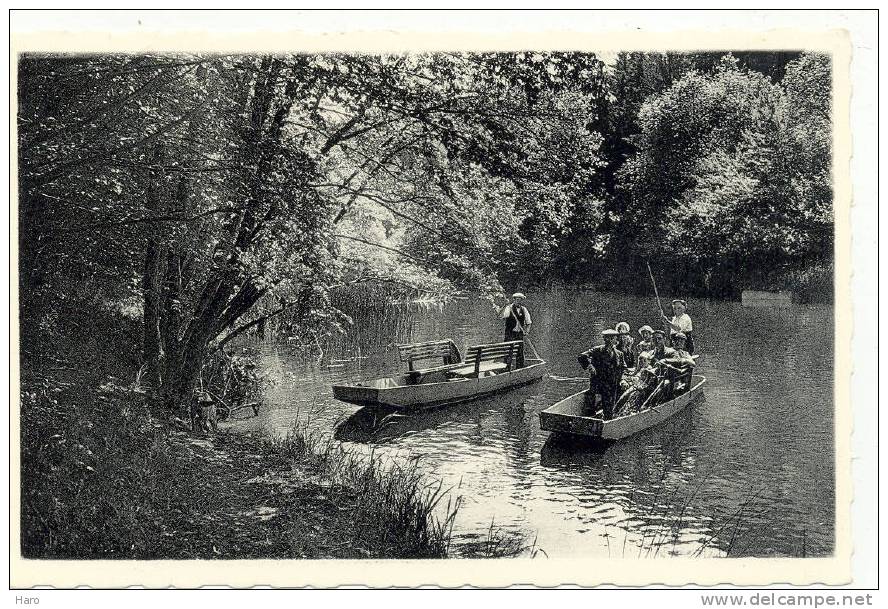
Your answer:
[577,299,694,419]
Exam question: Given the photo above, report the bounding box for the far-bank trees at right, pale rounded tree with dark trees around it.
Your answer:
[555,53,833,297]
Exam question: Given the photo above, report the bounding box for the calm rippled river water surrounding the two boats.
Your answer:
[237,291,834,557]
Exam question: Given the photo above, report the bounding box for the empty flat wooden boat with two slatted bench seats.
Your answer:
[333,341,546,412]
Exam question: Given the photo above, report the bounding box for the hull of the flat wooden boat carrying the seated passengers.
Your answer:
[540,375,706,440]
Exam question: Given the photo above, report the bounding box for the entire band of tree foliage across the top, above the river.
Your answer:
[18,52,832,406]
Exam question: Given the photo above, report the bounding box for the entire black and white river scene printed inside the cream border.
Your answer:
[11,8,868,583]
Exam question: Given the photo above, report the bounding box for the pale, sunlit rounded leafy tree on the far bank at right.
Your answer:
[621,55,832,293]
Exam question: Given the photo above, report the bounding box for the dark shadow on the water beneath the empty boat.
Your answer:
[333,383,539,444]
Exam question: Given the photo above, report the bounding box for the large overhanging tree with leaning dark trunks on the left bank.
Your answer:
[19,55,612,414]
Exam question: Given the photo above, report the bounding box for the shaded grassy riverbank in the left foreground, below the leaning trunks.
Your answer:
[20,312,518,559]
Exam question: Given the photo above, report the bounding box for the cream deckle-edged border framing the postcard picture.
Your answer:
[10,29,852,588]
